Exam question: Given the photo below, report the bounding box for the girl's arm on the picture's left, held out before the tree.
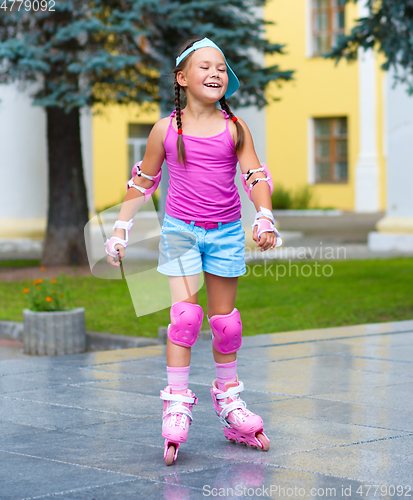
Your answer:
[107,118,169,266]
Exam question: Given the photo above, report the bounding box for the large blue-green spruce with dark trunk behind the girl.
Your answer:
[0,0,292,265]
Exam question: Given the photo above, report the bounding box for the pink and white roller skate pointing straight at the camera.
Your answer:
[161,385,198,465]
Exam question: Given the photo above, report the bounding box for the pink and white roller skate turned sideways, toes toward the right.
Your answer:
[211,379,270,451]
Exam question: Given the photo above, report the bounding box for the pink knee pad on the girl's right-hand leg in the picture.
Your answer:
[209,308,242,354]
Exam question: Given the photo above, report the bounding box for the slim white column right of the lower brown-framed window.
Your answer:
[354,2,380,212]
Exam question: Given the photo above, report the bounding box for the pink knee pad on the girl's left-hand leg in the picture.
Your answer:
[168,302,204,347]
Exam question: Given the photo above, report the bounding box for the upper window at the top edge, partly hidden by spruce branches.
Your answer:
[312,0,346,56]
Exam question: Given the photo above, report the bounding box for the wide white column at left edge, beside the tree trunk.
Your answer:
[0,84,47,238]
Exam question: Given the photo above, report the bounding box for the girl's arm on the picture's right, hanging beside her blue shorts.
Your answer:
[234,118,277,251]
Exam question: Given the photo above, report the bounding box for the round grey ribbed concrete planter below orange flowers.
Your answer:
[23,307,86,356]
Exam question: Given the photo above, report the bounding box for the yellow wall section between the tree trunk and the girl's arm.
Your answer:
[92,104,160,211]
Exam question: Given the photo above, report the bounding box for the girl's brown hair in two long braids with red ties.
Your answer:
[174,37,245,167]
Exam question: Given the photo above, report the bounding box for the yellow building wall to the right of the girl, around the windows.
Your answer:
[265,0,359,210]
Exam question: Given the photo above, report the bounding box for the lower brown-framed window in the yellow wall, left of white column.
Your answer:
[314,117,348,183]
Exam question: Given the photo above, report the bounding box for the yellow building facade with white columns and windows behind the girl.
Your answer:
[0,0,413,238]
